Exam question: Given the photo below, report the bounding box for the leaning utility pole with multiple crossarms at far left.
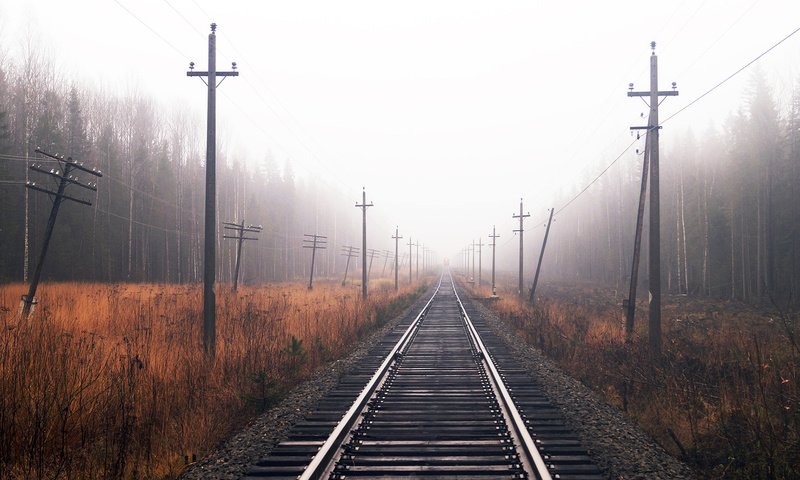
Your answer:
[22,148,103,319]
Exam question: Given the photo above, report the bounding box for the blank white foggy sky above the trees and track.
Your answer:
[0,0,800,262]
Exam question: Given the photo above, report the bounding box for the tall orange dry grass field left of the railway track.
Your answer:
[0,283,419,478]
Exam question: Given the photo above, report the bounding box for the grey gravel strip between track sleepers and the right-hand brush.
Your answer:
[469,299,697,480]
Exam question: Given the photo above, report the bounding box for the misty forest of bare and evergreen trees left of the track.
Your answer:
[0,47,360,282]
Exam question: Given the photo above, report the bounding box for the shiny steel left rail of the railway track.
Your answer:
[298,274,444,480]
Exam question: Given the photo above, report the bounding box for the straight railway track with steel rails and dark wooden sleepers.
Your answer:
[246,273,605,480]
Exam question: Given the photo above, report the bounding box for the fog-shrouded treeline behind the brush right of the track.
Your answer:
[545,71,800,307]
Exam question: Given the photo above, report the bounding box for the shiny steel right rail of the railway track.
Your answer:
[452,282,553,480]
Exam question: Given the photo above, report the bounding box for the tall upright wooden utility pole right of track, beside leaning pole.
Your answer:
[628,42,678,356]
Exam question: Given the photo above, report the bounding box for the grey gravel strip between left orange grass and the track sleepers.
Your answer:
[178,289,433,480]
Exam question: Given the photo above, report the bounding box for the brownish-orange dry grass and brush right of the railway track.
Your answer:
[466,274,800,479]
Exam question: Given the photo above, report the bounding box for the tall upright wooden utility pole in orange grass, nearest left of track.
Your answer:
[186,23,239,359]
